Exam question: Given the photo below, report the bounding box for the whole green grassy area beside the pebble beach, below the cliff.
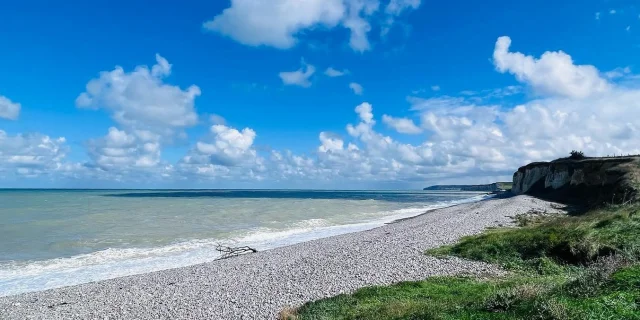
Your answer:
[282,205,640,320]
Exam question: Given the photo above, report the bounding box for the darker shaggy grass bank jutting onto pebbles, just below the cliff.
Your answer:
[428,202,640,269]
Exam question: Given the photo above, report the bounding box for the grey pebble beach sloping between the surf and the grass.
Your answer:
[0,196,557,319]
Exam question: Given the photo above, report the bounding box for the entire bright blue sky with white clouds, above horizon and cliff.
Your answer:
[0,0,640,189]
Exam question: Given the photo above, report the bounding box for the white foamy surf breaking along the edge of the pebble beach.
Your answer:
[0,195,490,296]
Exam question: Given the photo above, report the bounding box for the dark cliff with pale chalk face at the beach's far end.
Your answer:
[511,156,640,204]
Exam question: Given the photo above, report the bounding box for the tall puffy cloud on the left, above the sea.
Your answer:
[76,55,200,174]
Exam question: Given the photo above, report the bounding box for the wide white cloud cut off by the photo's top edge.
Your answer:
[203,0,420,52]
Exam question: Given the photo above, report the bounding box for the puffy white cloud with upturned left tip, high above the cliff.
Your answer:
[493,37,610,98]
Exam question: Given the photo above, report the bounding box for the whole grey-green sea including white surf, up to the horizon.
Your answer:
[0,189,489,296]
